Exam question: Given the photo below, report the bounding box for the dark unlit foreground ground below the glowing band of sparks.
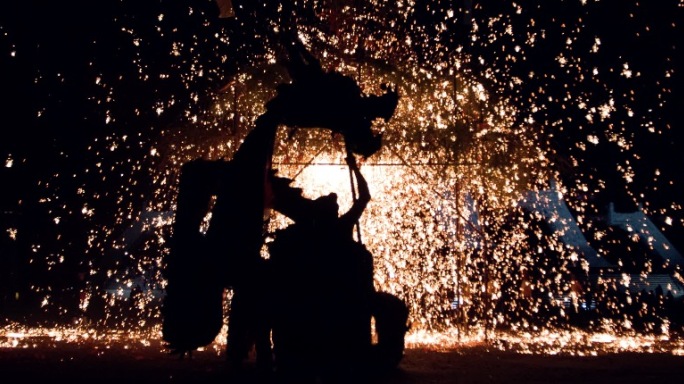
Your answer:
[0,342,684,384]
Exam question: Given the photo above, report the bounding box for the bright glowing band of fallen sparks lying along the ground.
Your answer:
[0,323,684,356]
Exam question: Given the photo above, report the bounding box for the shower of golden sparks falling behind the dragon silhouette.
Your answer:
[5,0,683,354]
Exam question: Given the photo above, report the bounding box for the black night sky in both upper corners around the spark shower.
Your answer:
[0,0,684,294]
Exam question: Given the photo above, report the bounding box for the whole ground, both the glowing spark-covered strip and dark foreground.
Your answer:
[0,324,684,384]
